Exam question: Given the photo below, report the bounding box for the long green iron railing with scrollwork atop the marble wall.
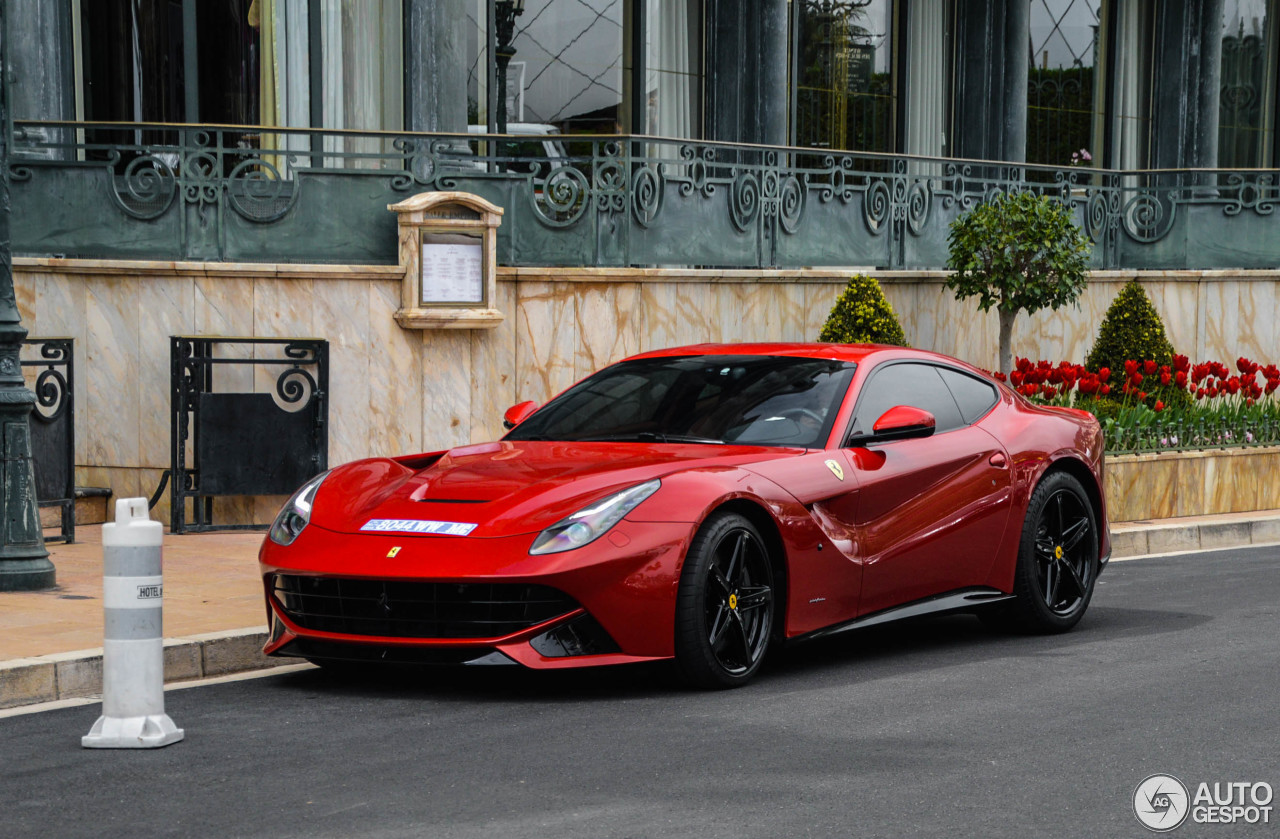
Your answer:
[9,122,1280,268]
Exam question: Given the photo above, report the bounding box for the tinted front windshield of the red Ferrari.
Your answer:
[506,355,854,448]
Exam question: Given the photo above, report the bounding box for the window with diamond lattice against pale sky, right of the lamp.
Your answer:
[507,0,623,134]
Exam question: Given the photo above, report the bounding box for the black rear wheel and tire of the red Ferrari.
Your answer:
[992,471,1098,634]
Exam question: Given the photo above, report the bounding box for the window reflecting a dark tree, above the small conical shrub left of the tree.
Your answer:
[791,0,895,151]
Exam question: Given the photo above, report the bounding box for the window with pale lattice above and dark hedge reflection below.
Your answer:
[1027,0,1103,167]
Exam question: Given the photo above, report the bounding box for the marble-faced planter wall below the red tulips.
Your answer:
[1106,446,1280,521]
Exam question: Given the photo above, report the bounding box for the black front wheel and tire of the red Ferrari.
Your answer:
[676,511,776,689]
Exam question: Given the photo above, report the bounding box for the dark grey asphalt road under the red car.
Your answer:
[0,547,1280,839]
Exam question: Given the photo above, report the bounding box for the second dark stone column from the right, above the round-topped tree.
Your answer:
[951,0,1030,161]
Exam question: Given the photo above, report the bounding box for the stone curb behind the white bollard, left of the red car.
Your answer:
[0,626,288,710]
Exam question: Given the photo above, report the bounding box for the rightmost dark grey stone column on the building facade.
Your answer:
[1149,0,1222,169]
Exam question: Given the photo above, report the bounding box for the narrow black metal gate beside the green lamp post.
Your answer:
[22,338,76,544]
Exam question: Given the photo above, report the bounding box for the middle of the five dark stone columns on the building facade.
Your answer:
[705,0,790,145]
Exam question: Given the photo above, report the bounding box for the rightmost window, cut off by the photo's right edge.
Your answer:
[1217,0,1276,169]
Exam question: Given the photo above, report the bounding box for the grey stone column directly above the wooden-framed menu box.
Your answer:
[404,0,467,133]
